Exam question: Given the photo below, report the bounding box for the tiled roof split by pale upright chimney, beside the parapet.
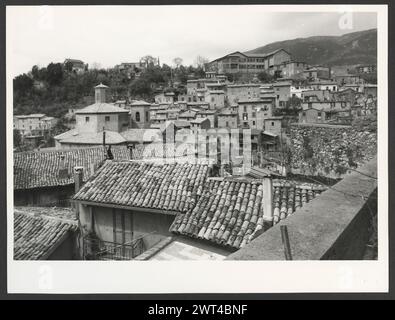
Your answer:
[170,179,323,248]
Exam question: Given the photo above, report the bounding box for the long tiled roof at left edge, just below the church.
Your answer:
[14,146,130,189]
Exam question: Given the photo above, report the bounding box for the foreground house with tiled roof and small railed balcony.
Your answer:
[74,161,209,260]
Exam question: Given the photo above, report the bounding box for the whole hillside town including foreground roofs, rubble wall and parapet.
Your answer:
[13,43,378,261]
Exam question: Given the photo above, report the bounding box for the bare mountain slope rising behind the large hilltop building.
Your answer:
[247,29,377,66]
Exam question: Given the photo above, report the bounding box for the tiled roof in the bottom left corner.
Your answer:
[14,207,77,260]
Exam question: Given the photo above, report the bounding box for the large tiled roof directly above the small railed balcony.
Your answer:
[73,161,212,212]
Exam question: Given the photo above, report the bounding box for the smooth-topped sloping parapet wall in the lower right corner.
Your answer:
[227,158,377,260]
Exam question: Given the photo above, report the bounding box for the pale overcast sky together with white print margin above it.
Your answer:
[7,6,377,76]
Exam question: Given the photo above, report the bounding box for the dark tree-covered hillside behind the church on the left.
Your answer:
[13,63,204,118]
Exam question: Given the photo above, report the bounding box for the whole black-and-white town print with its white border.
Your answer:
[6,5,388,293]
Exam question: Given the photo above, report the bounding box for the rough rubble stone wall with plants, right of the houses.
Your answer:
[289,124,377,178]
